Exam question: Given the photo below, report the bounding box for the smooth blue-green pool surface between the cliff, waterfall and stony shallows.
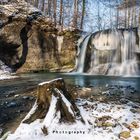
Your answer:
[0,73,140,94]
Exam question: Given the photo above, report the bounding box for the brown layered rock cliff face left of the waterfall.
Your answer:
[0,0,79,72]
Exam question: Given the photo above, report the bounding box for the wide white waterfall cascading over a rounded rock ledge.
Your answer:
[77,29,140,76]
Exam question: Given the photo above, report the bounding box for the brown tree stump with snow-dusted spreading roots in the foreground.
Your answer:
[23,78,84,124]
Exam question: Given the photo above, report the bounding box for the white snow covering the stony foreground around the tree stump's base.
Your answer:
[7,99,140,140]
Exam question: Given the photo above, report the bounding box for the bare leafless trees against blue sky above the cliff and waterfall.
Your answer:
[23,0,140,31]
